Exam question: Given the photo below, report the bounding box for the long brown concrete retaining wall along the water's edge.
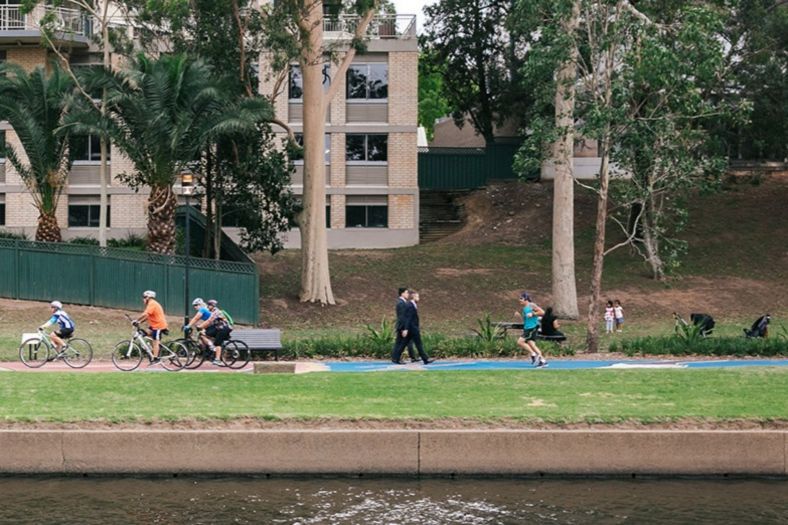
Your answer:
[0,430,788,476]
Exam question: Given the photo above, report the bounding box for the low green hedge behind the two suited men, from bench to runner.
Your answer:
[282,334,575,359]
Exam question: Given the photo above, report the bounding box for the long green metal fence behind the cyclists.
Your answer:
[0,239,259,324]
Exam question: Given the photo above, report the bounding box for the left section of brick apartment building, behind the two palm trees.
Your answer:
[0,0,147,240]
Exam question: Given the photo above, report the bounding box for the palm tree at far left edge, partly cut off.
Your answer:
[0,64,74,242]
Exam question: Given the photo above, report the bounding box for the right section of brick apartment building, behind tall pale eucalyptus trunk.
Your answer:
[261,15,419,248]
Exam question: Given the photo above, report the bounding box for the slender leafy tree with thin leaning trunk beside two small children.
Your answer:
[521,0,723,352]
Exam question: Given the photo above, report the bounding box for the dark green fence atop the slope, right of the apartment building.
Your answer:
[419,143,539,190]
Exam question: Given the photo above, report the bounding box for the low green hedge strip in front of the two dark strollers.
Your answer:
[610,336,788,357]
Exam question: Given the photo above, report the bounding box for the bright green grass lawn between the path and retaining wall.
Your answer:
[0,368,788,423]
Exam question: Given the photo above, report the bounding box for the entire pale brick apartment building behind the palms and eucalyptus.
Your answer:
[0,0,419,248]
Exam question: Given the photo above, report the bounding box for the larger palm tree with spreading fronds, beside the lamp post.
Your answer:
[67,55,272,254]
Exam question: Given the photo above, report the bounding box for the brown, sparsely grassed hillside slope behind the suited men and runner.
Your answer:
[257,178,788,335]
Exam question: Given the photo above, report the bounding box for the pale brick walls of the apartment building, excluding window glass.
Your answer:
[0,13,418,248]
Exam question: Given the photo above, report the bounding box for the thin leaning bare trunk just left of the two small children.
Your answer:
[586,142,610,353]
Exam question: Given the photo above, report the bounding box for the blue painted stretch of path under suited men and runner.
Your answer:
[321,359,788,372]
